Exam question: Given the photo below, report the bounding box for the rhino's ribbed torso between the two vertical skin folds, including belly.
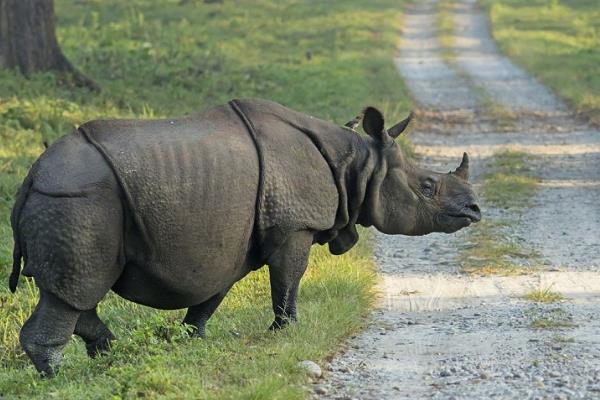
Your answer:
[82,106,259,308]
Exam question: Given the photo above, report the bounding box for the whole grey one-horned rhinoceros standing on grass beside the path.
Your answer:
[9,99,481,375]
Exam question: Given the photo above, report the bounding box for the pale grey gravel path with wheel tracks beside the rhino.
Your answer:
[315,0,600,399]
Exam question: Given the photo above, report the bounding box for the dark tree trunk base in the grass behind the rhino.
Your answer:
[0,0,99,90]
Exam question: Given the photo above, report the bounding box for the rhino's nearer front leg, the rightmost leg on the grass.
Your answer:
[269,231,313,330]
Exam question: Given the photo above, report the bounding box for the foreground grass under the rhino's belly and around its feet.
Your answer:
[0,239,374,399]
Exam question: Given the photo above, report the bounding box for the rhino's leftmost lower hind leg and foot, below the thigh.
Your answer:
[19,290,81,377]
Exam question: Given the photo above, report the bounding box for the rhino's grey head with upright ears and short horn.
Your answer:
[359,107,481,235]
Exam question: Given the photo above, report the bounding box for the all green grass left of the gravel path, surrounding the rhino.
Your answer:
[0,0,411,399]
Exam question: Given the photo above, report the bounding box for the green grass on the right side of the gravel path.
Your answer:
[482,0,600,124]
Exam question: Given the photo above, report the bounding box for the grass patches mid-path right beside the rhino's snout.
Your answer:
[459,150,538,275]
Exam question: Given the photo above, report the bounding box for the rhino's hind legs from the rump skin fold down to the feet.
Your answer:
[20,188,123,376]
